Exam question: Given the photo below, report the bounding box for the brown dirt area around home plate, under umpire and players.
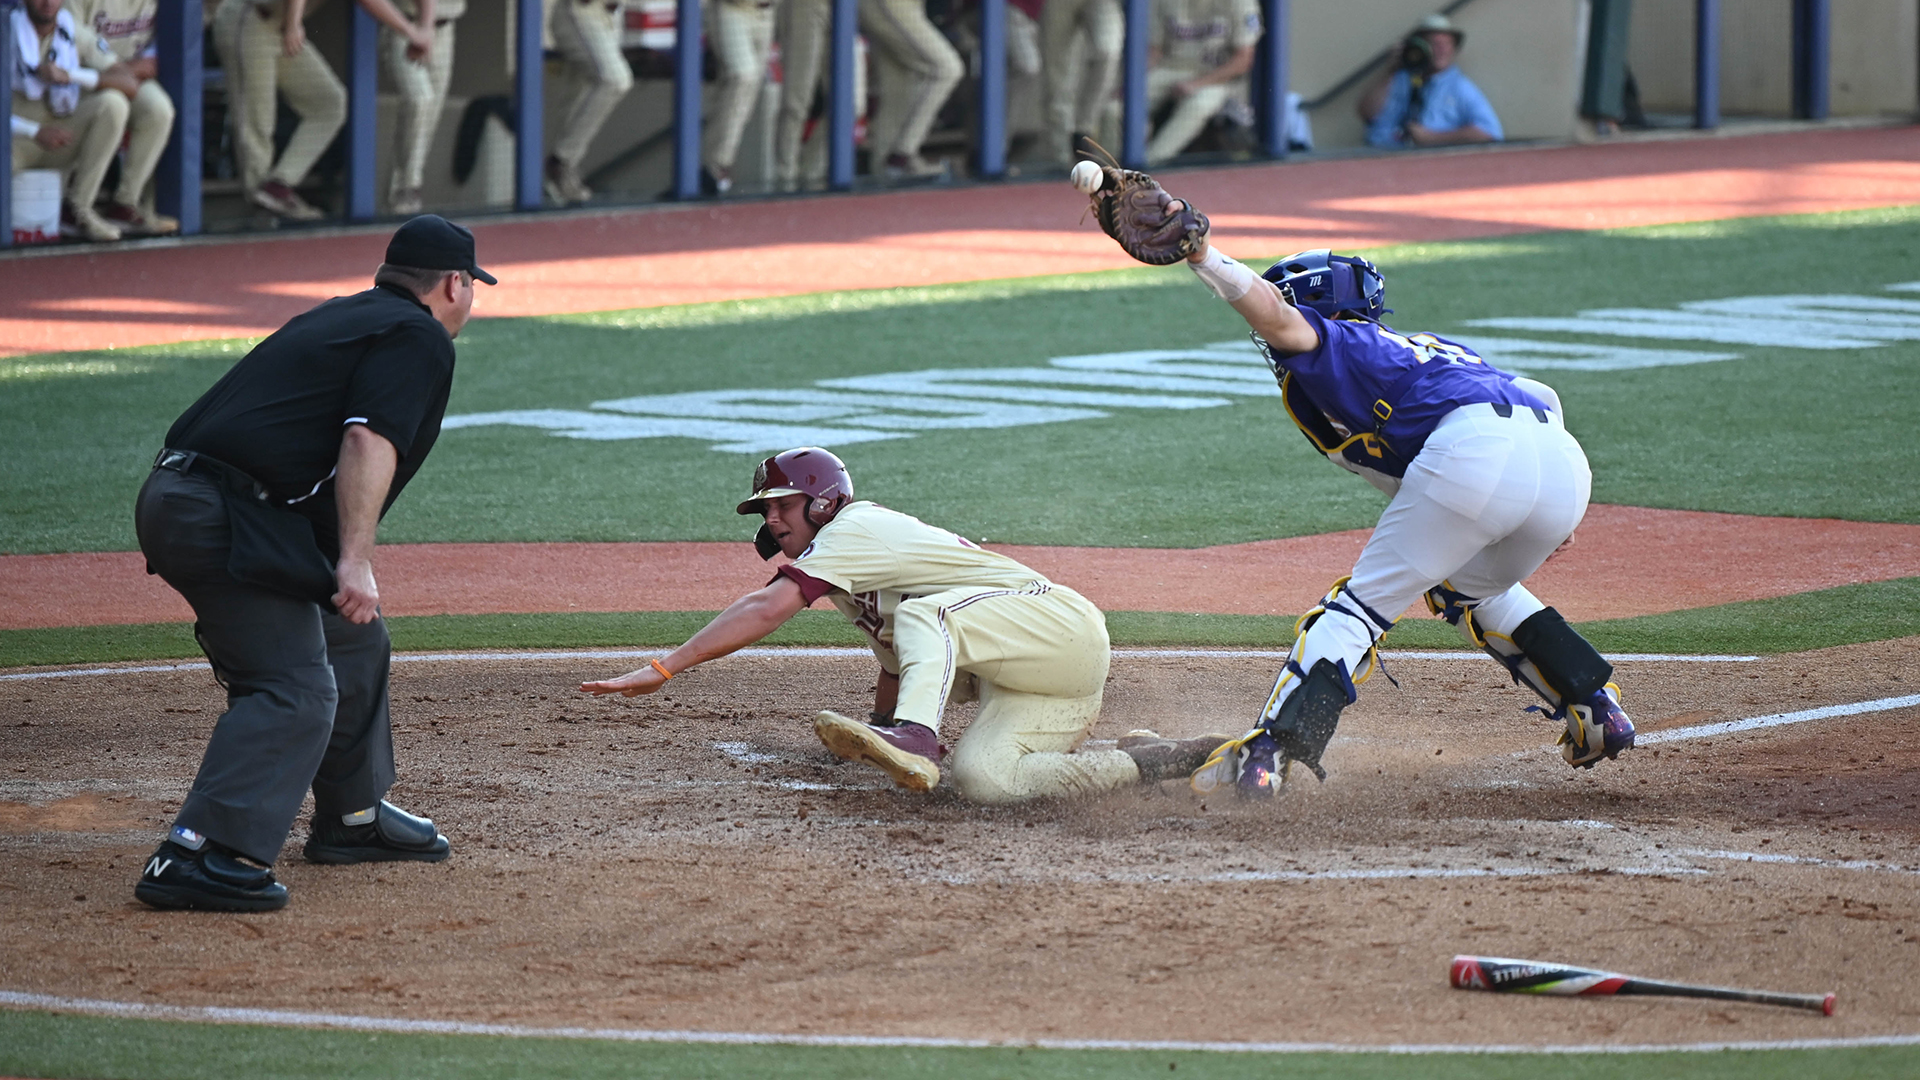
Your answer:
[0,640,1920,1045]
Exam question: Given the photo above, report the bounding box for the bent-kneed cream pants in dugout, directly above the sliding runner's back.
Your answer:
[860,0,966,167]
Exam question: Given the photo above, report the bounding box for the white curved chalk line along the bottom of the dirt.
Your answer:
[0,990,1920,1055]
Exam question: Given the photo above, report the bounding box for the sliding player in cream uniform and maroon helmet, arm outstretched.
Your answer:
[580,446,1227,803]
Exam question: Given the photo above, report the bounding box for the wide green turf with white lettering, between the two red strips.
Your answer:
[11,209,1920,553]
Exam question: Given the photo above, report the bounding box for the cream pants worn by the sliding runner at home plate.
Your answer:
[893,582,1140,803]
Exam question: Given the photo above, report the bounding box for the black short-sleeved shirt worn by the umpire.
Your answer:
[167,284,453,561]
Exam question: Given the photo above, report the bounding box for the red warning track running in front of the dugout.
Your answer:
[0,127,1920,356]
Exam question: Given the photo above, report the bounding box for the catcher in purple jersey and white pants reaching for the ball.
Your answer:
[1077,165,1634,796]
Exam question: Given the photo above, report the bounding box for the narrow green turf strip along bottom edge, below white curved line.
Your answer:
[0,1011,1920,1080]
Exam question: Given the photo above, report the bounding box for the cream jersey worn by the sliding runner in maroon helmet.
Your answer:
[776,502,1050,675]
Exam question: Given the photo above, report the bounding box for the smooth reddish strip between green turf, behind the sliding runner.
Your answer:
[11,505,1920,630]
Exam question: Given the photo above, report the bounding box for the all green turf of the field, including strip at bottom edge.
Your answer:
[0,208,1920,1080]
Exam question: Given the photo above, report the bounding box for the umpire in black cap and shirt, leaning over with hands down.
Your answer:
[134,213,495,911]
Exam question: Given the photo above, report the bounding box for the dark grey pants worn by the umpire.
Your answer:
[134,469,394,865]
